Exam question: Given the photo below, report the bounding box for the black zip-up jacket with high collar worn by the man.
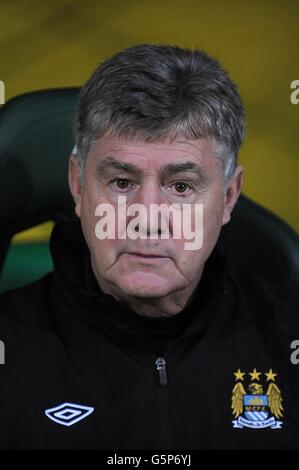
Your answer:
[0,222,299,450]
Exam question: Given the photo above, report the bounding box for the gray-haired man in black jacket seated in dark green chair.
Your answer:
[0,45,299,450]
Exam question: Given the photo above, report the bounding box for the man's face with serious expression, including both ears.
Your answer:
[70,137,242,299]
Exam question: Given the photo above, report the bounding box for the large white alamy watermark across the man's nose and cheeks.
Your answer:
[95,196,203,250]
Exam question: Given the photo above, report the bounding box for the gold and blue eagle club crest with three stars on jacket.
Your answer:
[231,369,283,429]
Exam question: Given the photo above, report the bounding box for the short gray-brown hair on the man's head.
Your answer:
[75,44,245,185]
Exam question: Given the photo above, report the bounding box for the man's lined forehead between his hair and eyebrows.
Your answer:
[91,137,216,171]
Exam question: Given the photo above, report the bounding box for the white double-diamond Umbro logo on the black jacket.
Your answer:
[45,402,94,426]
